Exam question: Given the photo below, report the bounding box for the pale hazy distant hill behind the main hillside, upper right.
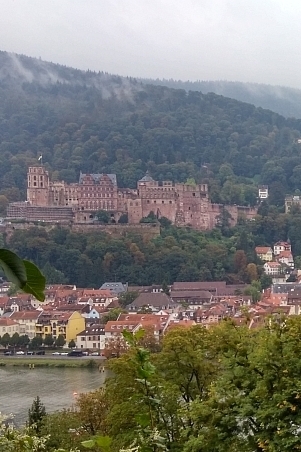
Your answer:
[141,79,301,118]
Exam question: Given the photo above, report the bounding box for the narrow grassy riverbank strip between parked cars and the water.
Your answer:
[0,356,104,370]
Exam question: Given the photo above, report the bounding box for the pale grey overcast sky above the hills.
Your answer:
[0,0,301,88]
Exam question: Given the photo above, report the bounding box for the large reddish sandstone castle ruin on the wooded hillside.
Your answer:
[7,166,257,230]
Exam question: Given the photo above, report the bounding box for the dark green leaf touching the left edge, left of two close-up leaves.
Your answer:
[0,249,27,289]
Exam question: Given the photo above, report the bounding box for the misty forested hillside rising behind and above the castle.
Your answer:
[0,52,301,211]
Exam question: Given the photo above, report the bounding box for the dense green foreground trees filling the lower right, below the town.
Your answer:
[4,320,301,452]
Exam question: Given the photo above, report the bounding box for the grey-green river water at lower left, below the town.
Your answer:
[0,367,107,426]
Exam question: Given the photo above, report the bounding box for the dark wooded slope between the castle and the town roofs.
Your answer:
[0,205,301,287]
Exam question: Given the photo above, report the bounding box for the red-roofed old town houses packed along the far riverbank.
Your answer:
[0,276,301,351]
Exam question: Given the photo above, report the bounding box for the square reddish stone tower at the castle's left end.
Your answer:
[27,166,49,207]
